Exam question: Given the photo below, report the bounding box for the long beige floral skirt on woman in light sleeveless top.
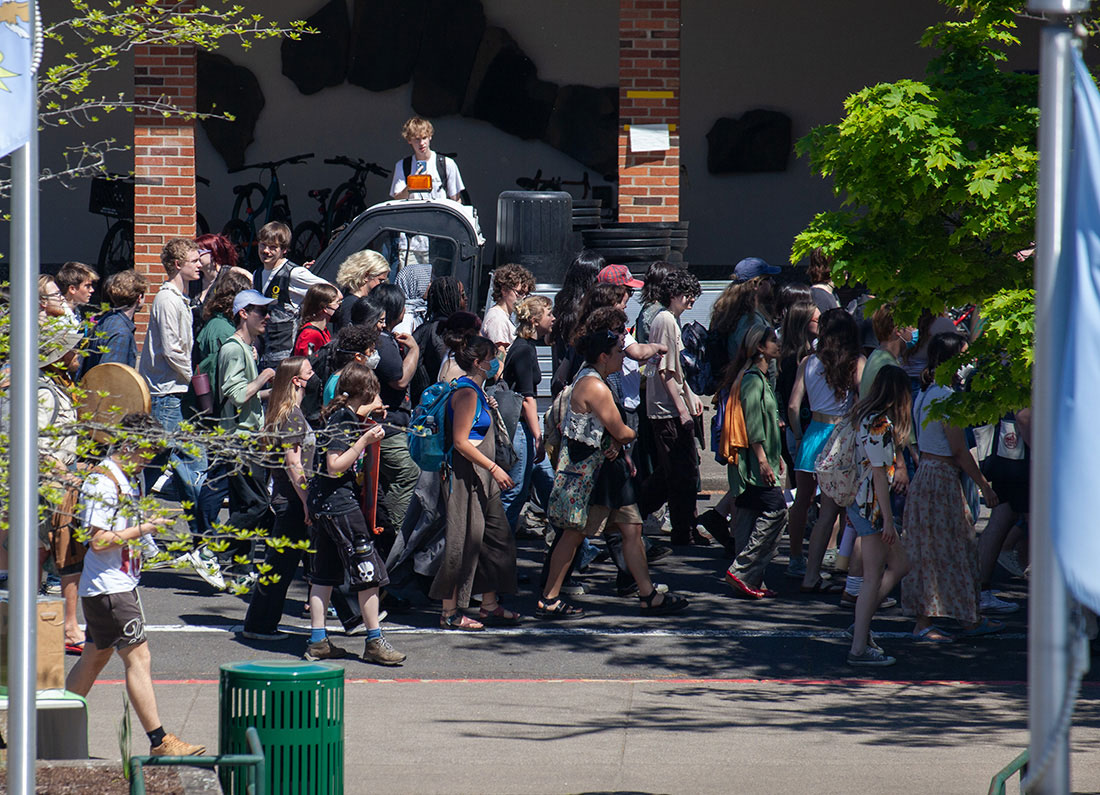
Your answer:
[901,457,980,623]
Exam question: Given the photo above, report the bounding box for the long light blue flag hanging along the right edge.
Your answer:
[1051,49,1100,612]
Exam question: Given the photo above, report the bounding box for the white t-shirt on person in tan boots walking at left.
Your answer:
[79,459,141,596]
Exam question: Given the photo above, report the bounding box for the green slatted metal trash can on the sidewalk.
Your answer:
[218,661,344,795]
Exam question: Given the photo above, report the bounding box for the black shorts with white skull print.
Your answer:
[307,510,389,590]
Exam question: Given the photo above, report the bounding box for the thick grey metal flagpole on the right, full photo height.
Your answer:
[1027,0,1089,795]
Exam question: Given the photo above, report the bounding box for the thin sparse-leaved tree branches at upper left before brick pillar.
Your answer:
[0,0,316,196]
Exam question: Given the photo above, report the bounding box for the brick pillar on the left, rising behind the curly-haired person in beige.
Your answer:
[133,0,196,339]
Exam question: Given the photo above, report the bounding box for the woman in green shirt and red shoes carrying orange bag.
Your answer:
[726,325,787,599]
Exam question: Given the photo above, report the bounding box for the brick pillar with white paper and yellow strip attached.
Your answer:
[618,0,681,221]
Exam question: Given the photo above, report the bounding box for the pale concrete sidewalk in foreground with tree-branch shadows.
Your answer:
[77,677,1100,795]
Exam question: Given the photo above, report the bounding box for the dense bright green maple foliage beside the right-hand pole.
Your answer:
[791,0,1038,422]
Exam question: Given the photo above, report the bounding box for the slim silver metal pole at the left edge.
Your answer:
[8,0,39,793]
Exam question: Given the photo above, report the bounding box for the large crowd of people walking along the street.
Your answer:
[12,119,1029,754]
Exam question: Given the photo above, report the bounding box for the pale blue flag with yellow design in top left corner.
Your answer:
[0,0,35,157]
